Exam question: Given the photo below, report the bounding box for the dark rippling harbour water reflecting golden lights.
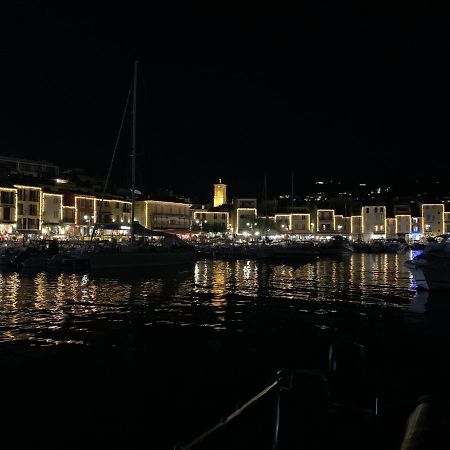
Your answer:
[0,253,450,448]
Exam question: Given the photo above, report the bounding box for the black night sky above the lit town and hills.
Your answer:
[0,1,450,200]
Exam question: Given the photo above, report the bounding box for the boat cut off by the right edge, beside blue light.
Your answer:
[405,235,450,291]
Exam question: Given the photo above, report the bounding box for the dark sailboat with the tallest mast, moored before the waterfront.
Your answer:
[78,61,196,270]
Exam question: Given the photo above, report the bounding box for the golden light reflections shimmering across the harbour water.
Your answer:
[0,253,415,345]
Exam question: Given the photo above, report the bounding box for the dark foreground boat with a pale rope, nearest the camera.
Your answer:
[174,341,436,450]
